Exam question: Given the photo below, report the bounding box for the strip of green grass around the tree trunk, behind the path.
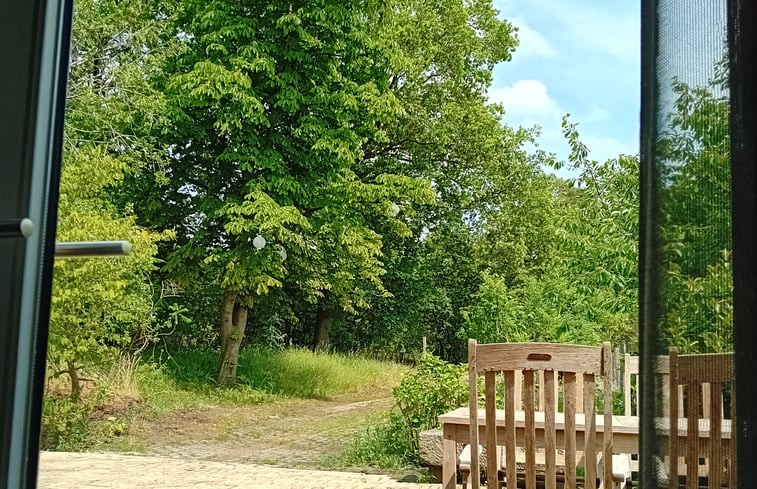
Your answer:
[42,349,407,450]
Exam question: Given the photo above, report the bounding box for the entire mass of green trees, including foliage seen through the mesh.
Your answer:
[50,0,731,404]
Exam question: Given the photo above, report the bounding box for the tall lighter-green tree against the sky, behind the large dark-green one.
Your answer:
[340,0,550,359]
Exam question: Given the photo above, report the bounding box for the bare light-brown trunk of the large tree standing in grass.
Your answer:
[217,290,252,386]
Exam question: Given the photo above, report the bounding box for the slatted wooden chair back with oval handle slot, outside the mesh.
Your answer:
[468,339,613,489]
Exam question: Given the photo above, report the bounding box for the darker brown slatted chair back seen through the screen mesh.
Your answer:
[668,348,736,489]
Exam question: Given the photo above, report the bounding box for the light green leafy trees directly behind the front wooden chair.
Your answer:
[460,117,639,347]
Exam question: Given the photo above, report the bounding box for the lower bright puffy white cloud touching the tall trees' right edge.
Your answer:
[489,80,560,117]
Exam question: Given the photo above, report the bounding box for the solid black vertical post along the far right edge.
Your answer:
[728,0,757,487]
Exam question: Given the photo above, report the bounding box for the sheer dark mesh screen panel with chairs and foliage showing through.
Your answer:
[642,0,734,487]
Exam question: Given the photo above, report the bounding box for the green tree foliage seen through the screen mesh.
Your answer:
[659,60,733,352]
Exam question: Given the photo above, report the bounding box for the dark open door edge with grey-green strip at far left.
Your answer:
[0,0,71,489]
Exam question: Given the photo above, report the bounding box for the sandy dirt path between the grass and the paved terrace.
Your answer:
[118,388,392,468]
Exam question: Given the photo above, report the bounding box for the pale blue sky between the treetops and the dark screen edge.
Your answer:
[489,0,640,165]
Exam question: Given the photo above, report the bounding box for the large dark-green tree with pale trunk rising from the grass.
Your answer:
[132,0,432,385]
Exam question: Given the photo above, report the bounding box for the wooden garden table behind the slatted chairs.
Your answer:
[439,407,731,489]
